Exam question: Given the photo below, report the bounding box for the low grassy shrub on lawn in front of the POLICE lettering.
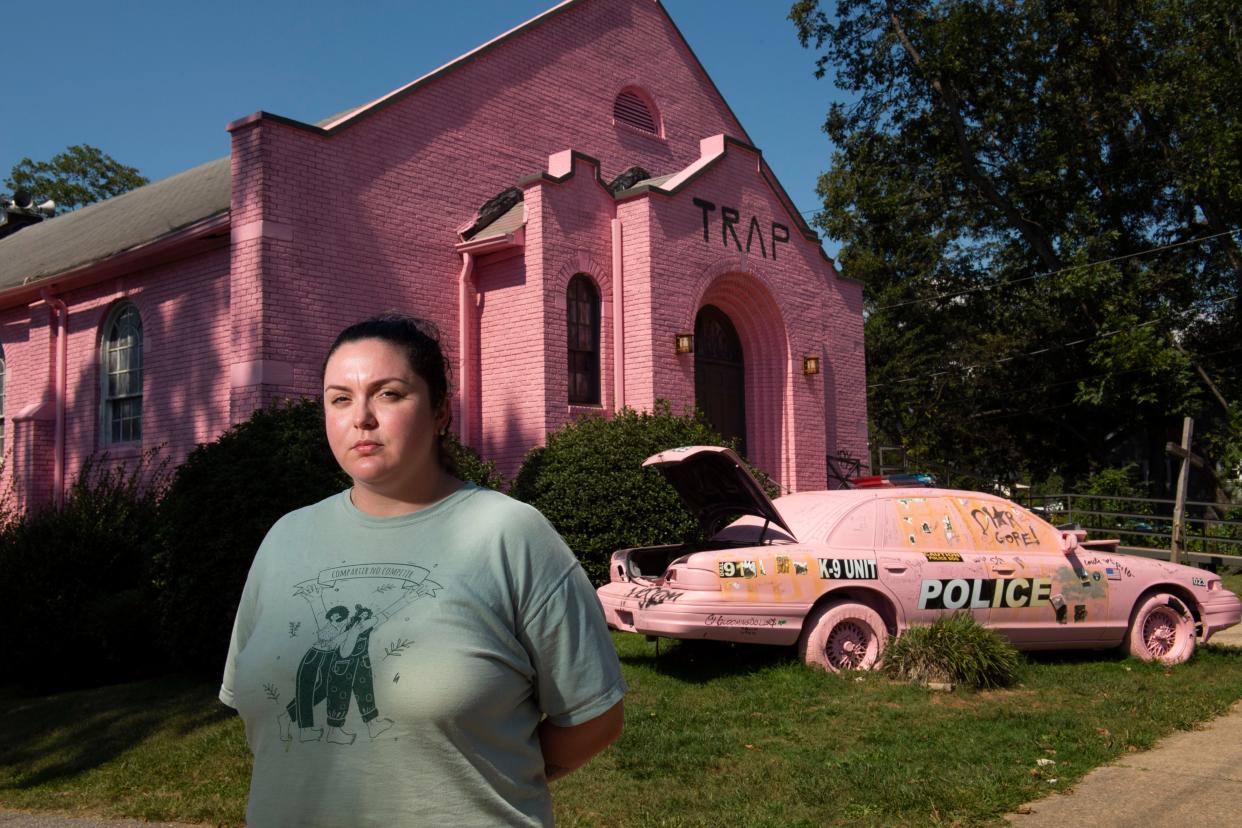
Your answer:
[884,612,1022,690]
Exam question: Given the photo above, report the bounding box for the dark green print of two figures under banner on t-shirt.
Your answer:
[268,564,443,745]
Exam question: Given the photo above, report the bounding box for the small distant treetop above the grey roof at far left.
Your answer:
[5,144,148,214]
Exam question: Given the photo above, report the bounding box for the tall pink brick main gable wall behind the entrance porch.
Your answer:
[221,0,741,433]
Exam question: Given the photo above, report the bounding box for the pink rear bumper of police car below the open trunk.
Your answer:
[596,580,807,644]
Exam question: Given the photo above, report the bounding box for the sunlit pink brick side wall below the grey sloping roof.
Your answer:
[5,247,230,505]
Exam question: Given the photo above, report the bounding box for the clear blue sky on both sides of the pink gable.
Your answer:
[0,0,840,254]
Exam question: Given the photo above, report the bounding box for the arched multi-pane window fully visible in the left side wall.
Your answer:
[101,302,143,444]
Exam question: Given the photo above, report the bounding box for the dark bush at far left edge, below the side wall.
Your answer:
[0,452,165,693]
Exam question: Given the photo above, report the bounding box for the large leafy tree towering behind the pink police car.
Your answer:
[790,0,1242,489]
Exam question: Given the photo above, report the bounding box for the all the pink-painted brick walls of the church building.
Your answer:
[0,0,866,506]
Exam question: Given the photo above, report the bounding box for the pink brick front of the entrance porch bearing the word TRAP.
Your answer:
[622,144,866,489]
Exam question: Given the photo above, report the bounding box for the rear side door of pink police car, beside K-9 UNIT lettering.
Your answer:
[878,490,990,624]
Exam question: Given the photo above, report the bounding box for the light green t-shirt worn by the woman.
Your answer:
[220,485,626,828]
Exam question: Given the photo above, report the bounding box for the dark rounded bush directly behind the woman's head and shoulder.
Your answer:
[152,398,502,677]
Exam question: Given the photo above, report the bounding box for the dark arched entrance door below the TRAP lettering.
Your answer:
[694,305,746,454]
